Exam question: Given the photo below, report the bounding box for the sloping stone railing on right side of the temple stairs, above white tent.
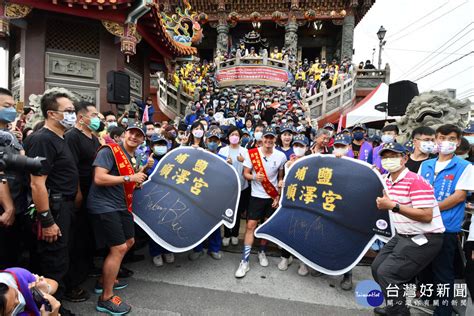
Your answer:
[304,78,355,120]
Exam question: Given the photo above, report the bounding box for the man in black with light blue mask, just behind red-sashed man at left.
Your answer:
[64,101,100,302]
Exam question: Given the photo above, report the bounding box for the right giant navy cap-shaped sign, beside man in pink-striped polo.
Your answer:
[255,155,394,275]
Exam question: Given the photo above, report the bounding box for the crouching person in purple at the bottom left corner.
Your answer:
[0,268,61,316]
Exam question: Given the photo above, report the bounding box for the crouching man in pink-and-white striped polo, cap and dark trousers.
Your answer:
[372,143,445,315]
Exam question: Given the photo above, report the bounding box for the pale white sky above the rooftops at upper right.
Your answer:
[353,0,474,102]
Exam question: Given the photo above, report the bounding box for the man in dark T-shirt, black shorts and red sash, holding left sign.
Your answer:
[87,126,153,315]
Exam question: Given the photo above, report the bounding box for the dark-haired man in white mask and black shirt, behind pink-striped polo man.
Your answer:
[405,126,435,173]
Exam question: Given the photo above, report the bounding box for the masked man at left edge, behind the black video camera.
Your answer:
[0,88,27,269]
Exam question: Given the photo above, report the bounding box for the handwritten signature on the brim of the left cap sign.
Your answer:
[140,185,189,240]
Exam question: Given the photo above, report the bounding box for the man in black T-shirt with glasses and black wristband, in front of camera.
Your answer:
[25,92,79,315]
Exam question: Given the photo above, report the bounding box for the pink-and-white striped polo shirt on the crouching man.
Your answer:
[385,168,444,235]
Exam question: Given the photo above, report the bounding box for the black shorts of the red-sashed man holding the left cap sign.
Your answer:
[91,210,135,249]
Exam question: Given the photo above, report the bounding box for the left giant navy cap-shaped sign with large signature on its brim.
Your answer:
[133,147,240,252]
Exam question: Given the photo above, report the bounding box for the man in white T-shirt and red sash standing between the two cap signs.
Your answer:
[235,127,286,278]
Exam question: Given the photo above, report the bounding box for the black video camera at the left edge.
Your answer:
[0,131,46,172]
